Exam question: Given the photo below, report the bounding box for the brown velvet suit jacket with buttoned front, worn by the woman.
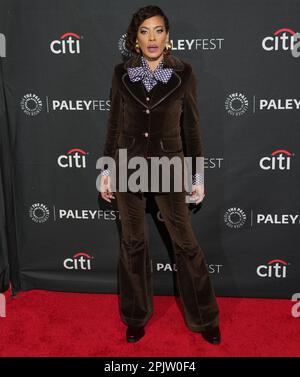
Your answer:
[103,55,203,192]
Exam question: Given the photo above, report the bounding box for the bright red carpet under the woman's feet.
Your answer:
[0,290,300,357]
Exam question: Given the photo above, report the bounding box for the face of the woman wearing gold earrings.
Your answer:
[137,16,169,60]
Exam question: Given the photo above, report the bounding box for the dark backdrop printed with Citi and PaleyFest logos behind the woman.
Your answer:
[0,0,300,298]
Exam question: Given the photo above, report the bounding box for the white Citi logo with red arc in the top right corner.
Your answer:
[262,28,296,51]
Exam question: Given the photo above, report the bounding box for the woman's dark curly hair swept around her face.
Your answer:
[125,5,171,54]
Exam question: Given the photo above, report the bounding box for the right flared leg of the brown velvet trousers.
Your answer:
[155,192,219,332]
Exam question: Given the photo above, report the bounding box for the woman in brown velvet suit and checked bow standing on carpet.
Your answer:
[100,6,220,344]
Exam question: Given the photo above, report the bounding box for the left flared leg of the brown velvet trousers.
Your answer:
[115,192,153,326]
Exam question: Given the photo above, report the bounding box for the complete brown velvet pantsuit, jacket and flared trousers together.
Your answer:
[103,55,219,331]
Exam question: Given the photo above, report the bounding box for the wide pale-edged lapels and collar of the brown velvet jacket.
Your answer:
[122,55,184,109]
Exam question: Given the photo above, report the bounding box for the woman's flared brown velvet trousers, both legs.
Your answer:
[115,191,219,332]
